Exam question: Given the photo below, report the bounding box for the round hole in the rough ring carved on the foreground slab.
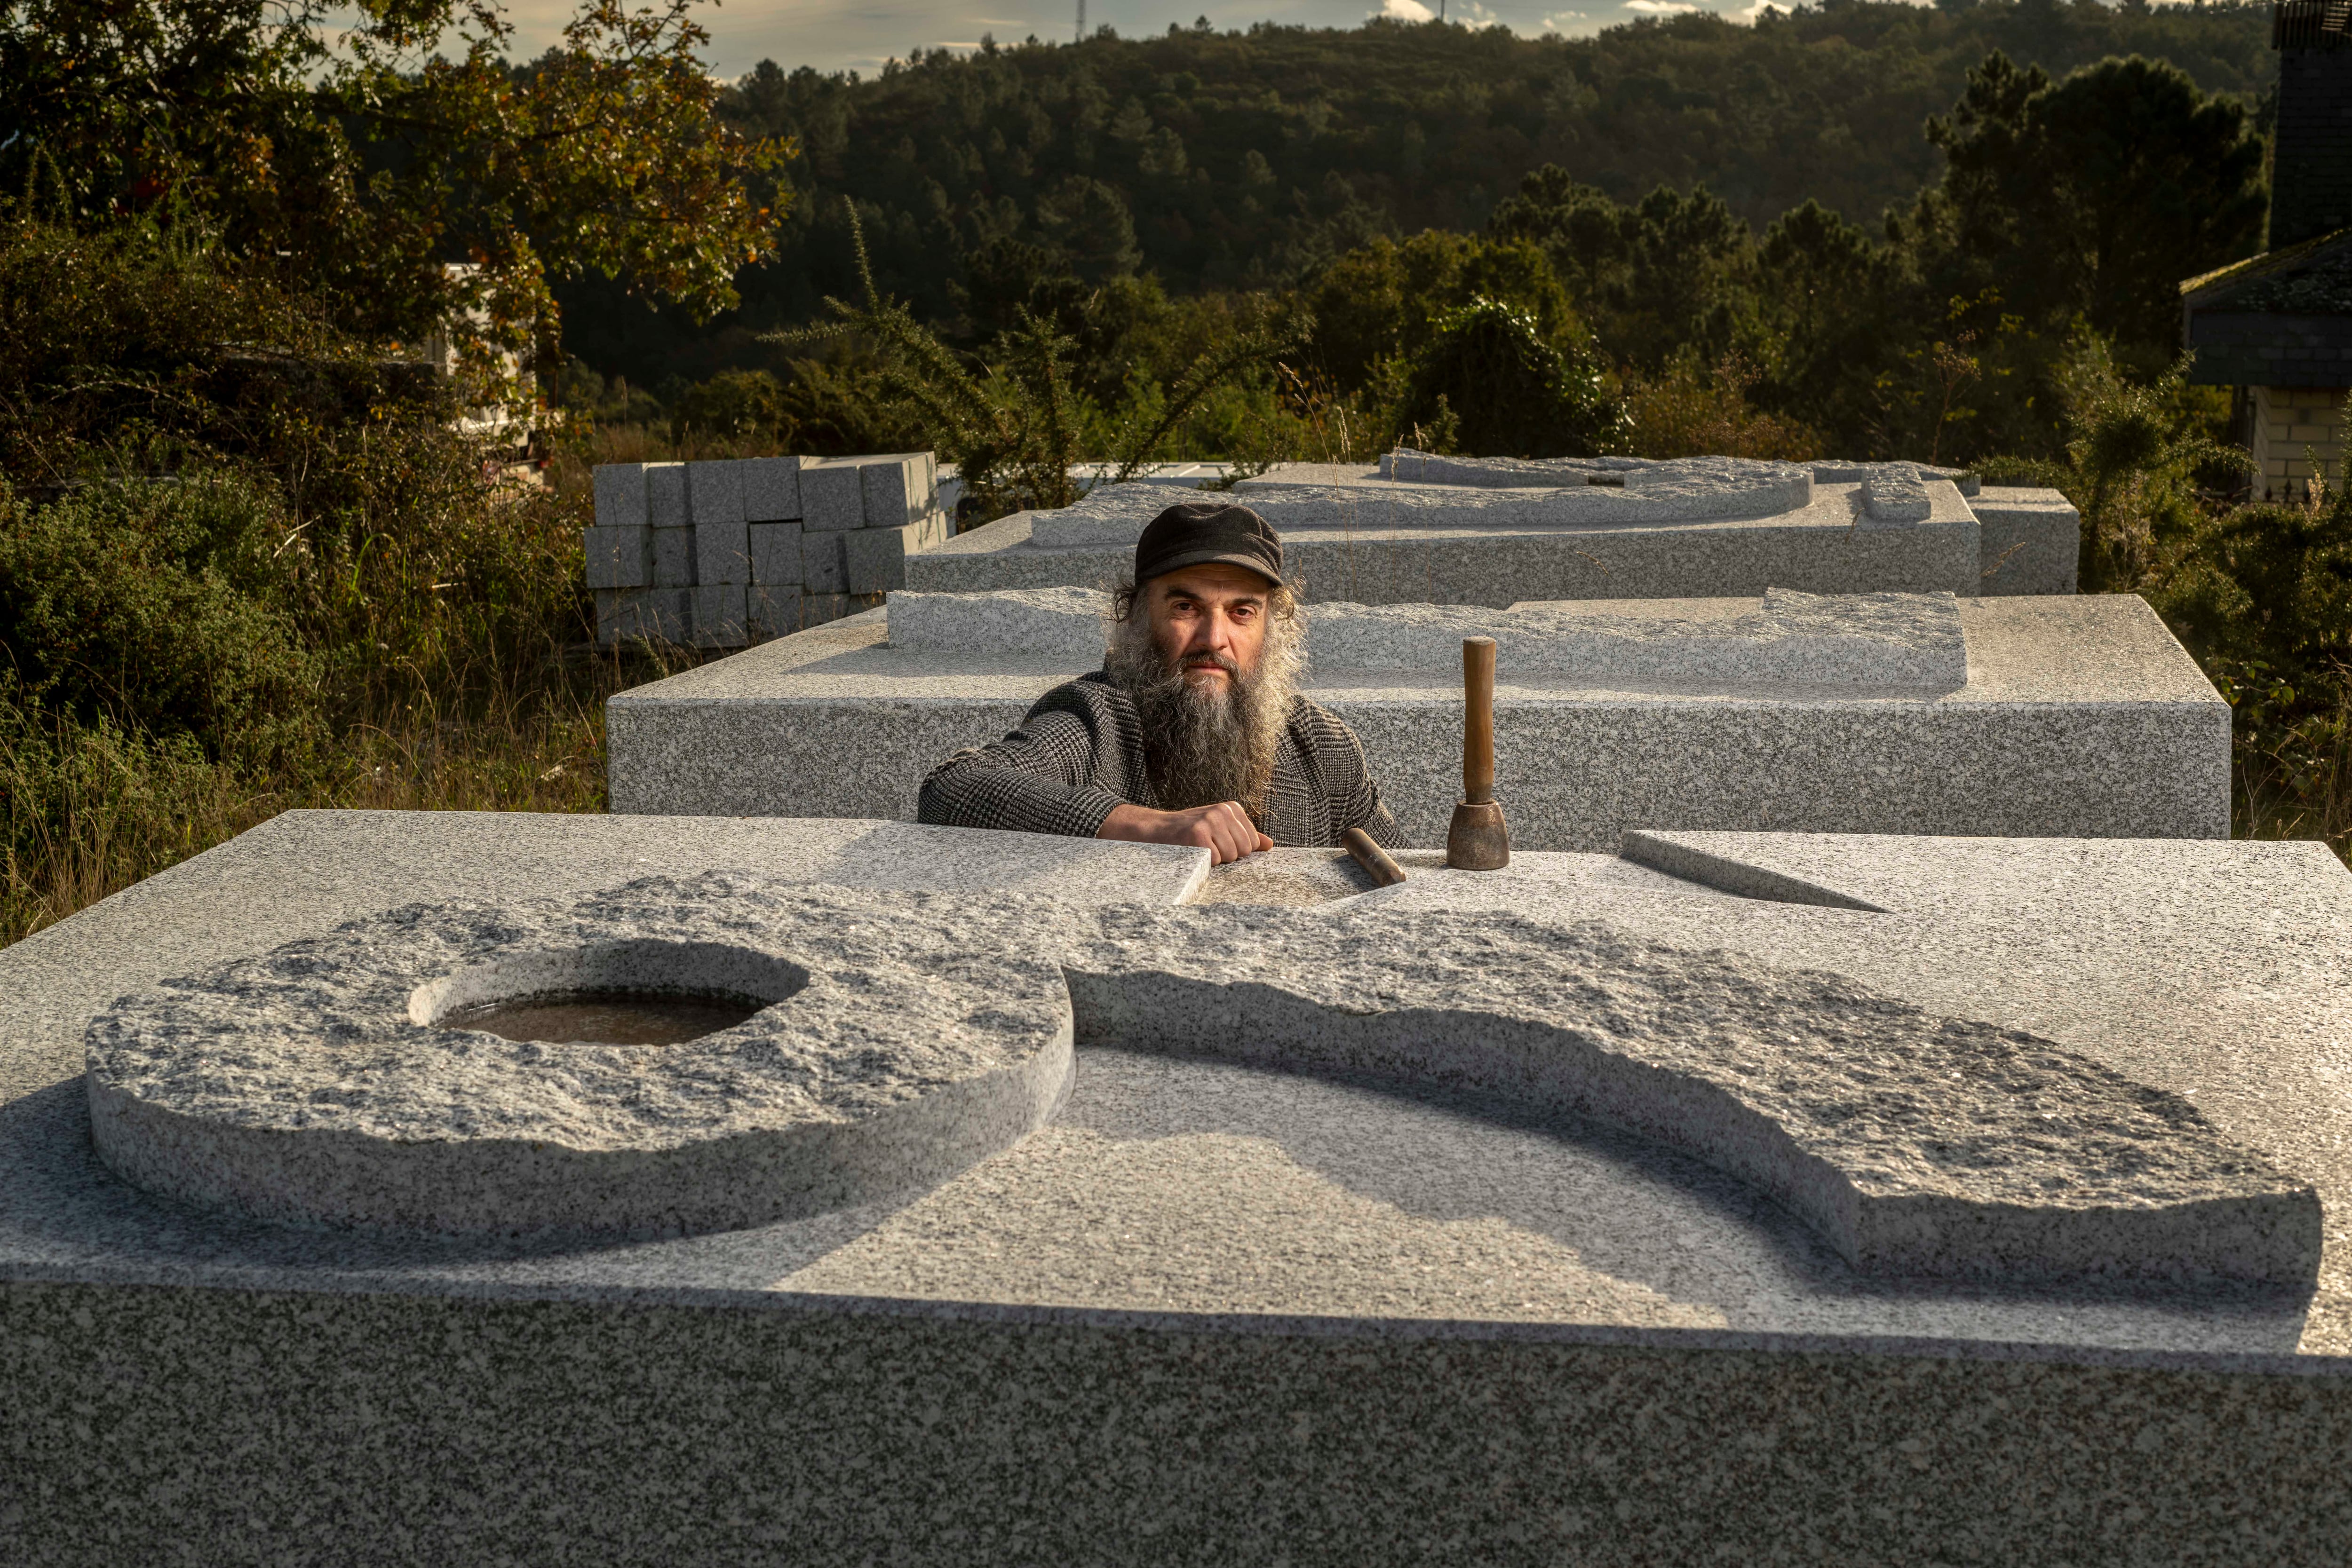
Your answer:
[409,940,809,1046]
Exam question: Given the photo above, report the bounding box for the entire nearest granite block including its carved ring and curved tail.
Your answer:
[0,813,2352,1563]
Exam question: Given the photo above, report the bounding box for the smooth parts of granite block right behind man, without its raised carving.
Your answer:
[607,595,2230,851]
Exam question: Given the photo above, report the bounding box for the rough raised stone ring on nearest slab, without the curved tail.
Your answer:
[87,879,1070,1234]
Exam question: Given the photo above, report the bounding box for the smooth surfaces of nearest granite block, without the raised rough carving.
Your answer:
[0,813,2352,1563]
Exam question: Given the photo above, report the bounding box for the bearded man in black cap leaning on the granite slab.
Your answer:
[917,506,1402,865]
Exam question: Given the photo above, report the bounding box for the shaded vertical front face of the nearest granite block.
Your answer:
[14,1283,2352,1568]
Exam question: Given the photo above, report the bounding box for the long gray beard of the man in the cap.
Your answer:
[1103,604,1303,827]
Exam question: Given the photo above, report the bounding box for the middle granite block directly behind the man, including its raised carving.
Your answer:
[604,588,2230,851]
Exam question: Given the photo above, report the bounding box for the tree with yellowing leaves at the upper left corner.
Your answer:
[0,0,790,369]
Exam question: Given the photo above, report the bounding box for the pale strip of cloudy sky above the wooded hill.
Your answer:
[487,0,1778,78]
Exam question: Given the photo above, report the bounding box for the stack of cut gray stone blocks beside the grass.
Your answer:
[586,451,953,649]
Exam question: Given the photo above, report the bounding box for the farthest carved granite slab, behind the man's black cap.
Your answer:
[908,459,2079,609]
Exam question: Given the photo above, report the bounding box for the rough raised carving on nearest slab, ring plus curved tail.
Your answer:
[87,872,2319,1283]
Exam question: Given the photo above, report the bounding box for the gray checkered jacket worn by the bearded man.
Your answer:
[917,673,1404,848]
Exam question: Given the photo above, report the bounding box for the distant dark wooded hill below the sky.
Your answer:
[550,0,2274,386]
